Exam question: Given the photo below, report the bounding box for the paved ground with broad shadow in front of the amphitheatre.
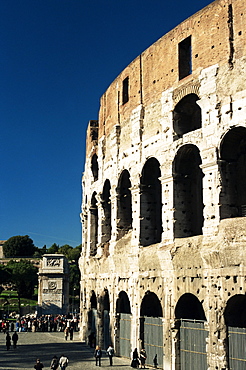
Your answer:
[0,332,131,370]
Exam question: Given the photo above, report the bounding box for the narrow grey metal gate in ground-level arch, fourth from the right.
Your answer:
[119,313,131,358]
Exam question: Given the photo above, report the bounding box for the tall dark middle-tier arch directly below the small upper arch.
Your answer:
[173,144,204,238]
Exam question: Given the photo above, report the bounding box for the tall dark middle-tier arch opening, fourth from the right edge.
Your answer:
[117,170,132,239]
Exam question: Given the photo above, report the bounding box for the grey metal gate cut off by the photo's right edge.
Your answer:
[228,326,246,370]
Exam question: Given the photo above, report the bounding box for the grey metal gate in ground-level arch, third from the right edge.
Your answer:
[140,316,163,369]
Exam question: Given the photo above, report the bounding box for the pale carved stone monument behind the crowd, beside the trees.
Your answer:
[38,254,69,315]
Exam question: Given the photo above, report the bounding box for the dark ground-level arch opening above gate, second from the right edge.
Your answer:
[175,293,206,321]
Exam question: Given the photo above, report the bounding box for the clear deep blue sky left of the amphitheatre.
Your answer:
[0,0,212,247]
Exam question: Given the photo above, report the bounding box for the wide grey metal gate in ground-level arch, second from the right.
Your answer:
[180,319,208,370]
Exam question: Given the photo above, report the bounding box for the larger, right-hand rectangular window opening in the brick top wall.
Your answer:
[179,36,192,80]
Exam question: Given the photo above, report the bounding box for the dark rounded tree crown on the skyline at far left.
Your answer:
[3,235,35,258]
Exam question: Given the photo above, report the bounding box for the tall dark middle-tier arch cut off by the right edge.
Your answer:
[219,127,246,219]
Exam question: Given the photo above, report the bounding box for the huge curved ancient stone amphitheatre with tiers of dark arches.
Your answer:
[80,0,246,370]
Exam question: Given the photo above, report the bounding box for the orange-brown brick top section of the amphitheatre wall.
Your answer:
[87,0,246,155]
